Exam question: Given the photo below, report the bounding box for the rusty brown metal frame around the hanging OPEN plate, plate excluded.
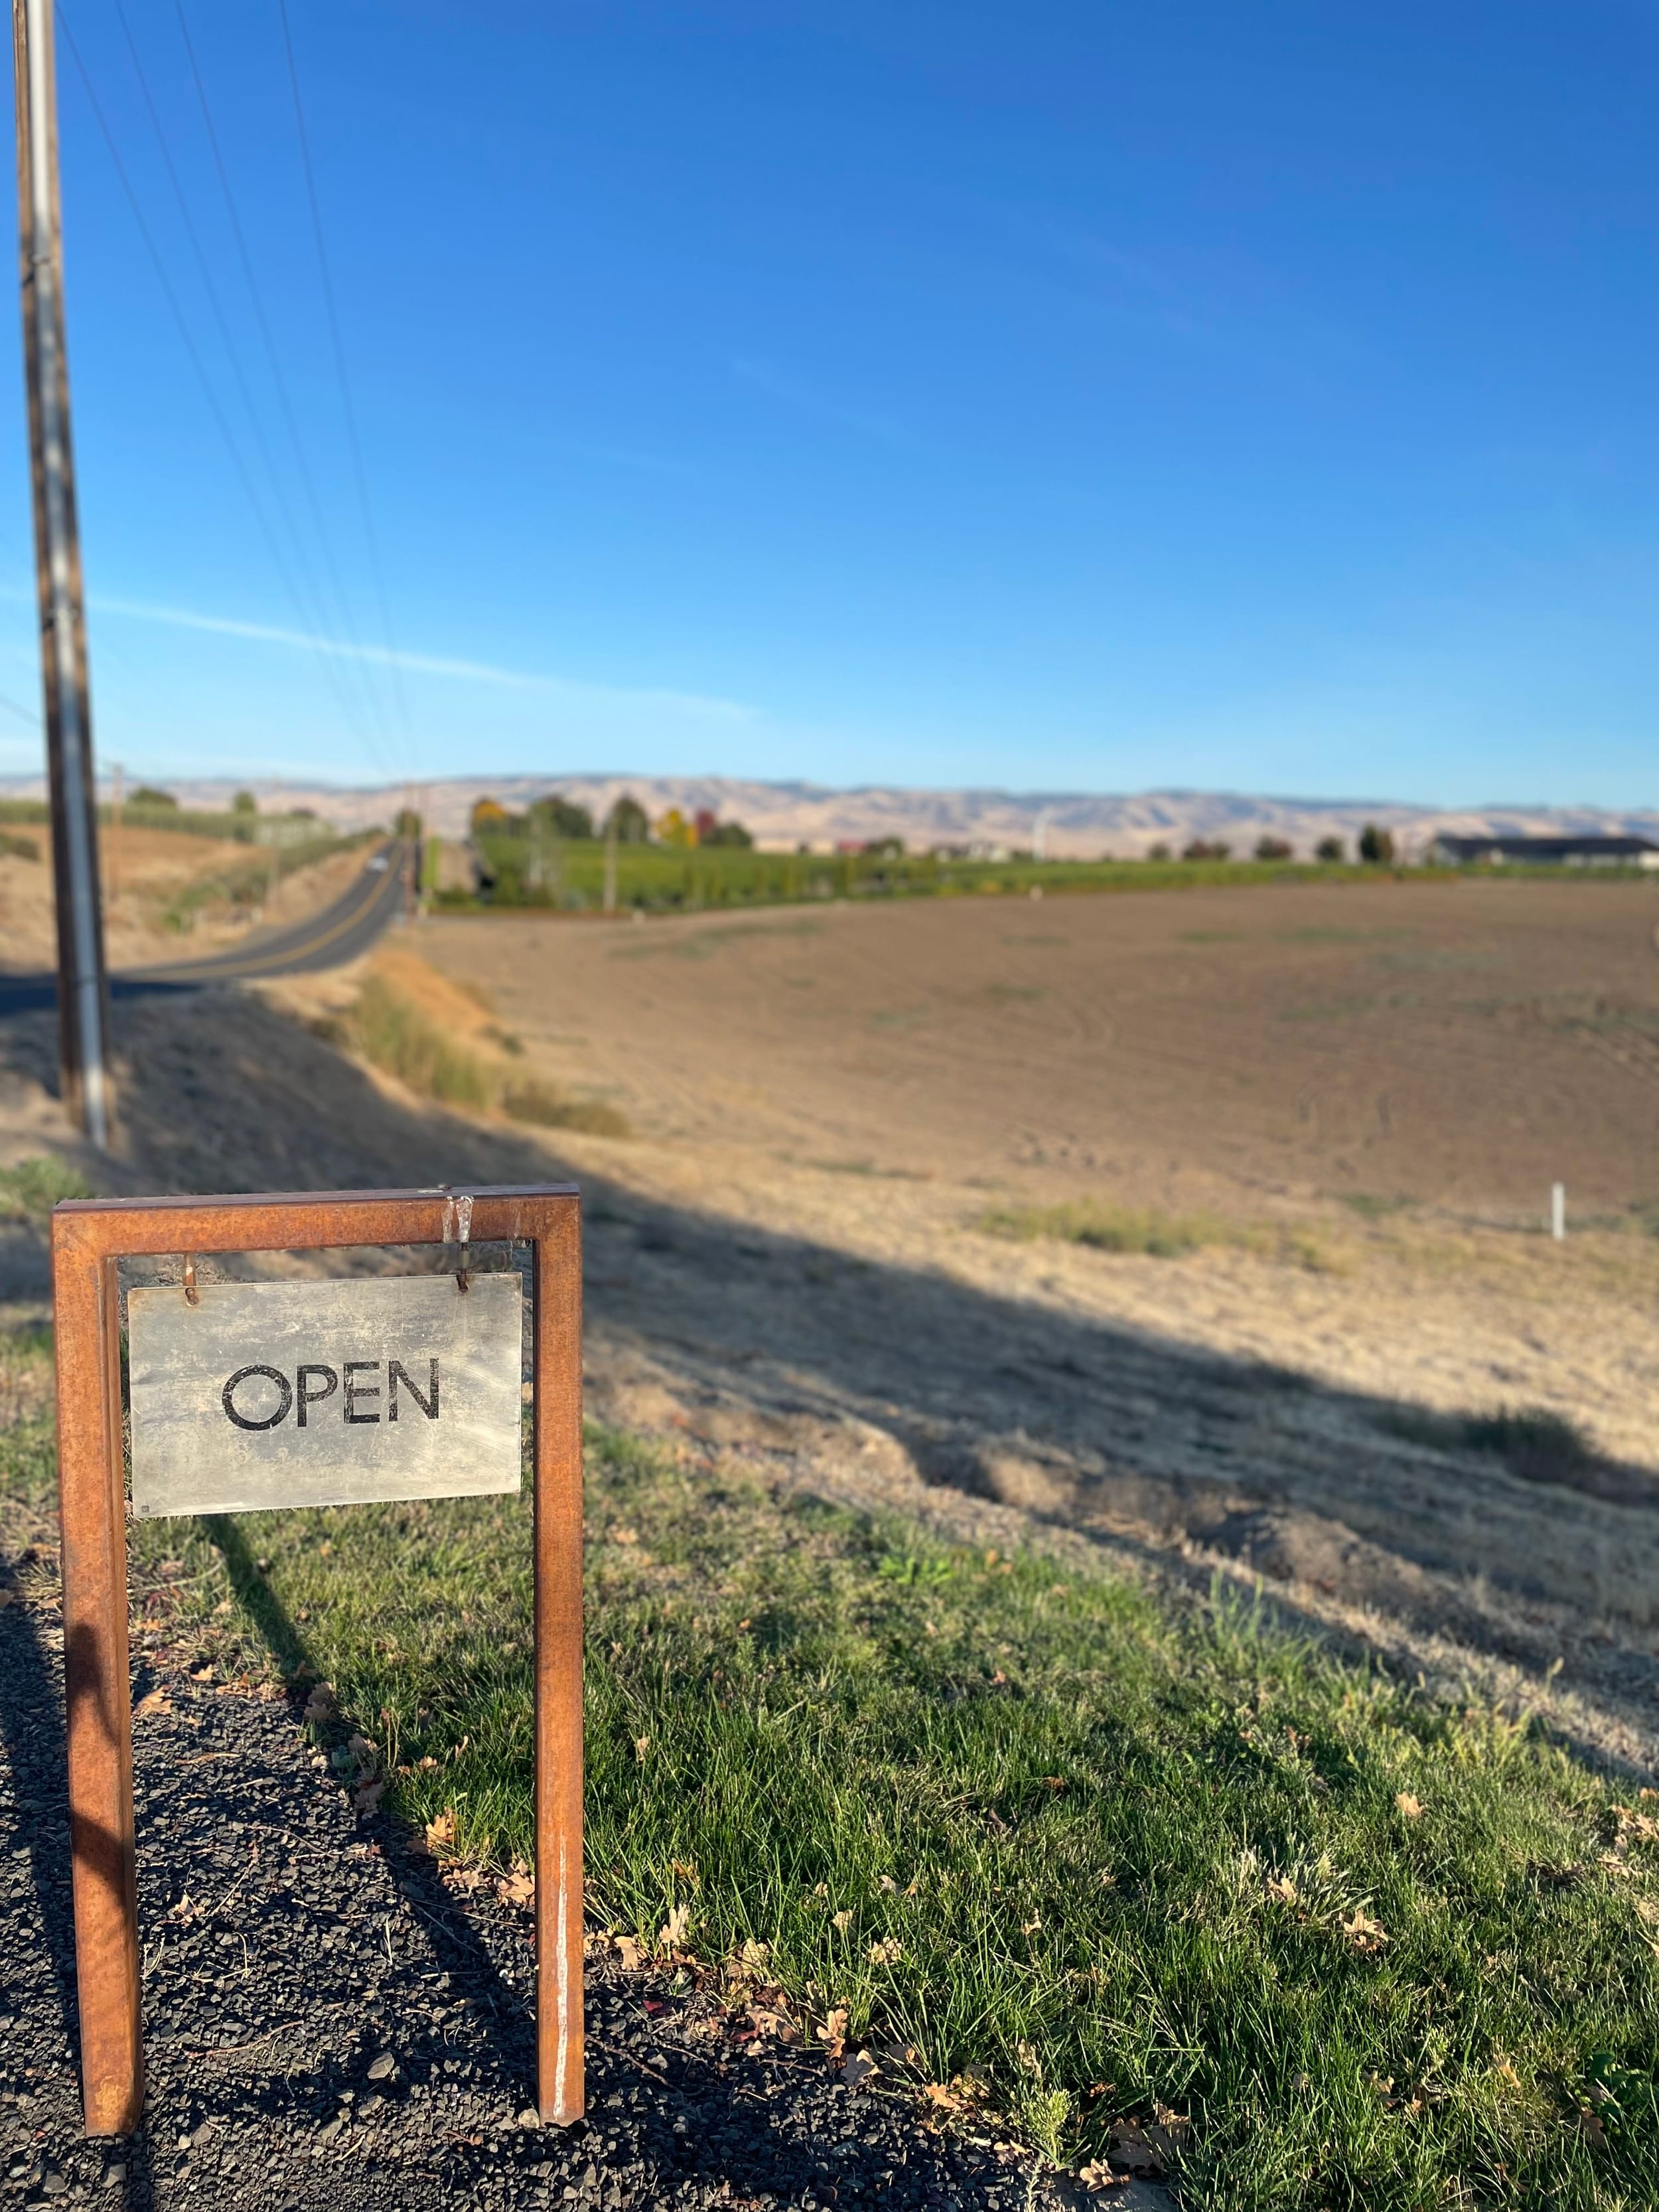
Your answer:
[51,1183,584,2134]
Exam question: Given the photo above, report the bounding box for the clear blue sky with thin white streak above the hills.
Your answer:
[0,0,1659,805]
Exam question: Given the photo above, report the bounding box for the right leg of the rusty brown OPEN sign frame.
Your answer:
[536,1208,586,2128]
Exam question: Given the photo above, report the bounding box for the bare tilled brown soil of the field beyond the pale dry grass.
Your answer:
[425,883,1659,1223]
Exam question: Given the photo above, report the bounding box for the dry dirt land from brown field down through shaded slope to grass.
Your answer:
[0,883,1659,1774]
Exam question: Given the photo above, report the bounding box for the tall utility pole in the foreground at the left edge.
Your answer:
[11,0,115,1150]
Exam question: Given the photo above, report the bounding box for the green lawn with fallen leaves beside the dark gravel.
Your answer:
[0,1424,1659,2212]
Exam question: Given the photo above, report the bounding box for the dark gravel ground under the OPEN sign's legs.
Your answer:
[0,1603,1168,2212]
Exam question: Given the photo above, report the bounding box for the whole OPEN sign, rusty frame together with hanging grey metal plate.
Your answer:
[51,1183,584,2134]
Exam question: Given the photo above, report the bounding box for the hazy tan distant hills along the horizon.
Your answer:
[0,774,1659,858]
